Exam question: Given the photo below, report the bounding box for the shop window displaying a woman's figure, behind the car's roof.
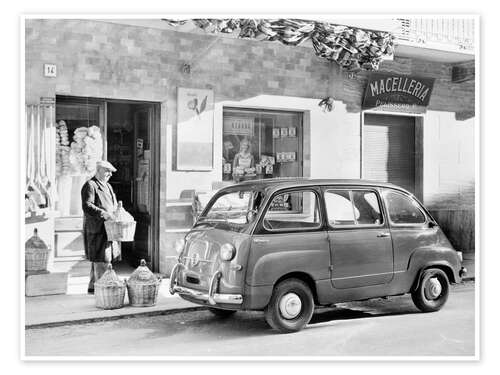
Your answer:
[222,109,303,182]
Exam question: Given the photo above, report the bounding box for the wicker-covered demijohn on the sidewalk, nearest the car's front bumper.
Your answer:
[126,259,161,306]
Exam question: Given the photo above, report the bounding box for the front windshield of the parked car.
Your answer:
[198,190,262,232]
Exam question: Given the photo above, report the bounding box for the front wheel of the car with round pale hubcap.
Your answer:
[264,279,314,333]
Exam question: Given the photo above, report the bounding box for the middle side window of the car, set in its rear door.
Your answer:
[324,190,383,226]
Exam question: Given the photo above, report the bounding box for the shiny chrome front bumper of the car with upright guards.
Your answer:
[169,263,243,305]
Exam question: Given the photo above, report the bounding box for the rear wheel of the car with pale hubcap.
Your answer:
[411,268,450,312]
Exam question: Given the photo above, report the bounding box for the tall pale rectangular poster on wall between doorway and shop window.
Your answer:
[176,87,214,171]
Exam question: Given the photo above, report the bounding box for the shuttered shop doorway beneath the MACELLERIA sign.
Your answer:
[362,113,422,198]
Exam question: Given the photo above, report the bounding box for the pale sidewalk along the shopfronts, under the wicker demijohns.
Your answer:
[25,259,475,328]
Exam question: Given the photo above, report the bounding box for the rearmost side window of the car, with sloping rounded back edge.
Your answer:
[384,191,426,224]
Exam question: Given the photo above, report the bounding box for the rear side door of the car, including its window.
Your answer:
[324,187,394,289]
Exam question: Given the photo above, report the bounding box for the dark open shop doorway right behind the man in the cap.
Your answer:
[106,101,158,268]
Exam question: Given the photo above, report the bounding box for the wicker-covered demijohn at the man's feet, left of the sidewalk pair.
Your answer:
[94,263,126,310]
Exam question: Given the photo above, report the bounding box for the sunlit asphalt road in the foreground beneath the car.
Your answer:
[25,282,475,356]
